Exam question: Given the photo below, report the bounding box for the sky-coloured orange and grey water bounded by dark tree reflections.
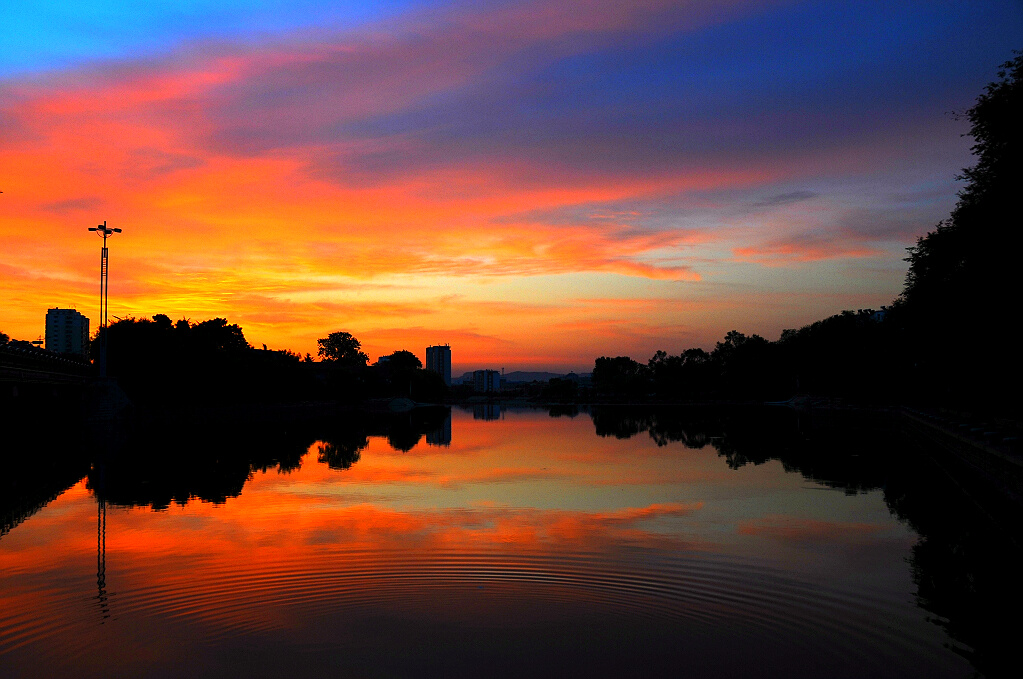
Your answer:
[0,415,971,679]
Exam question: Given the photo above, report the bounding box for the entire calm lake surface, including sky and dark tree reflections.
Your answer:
[0,407,1019,677]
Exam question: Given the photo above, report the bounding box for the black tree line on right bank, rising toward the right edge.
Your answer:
[593,53,1023,417]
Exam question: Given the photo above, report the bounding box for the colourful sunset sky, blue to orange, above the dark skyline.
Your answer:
[0,0,1023,374]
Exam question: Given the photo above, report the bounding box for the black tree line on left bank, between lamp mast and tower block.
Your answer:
[91,314,446,407]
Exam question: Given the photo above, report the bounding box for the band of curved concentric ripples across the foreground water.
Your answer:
[0,548,949,669]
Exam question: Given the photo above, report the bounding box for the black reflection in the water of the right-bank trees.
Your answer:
[592,407,1023,676]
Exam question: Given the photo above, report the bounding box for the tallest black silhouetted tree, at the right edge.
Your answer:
[895,54,1023,409]
